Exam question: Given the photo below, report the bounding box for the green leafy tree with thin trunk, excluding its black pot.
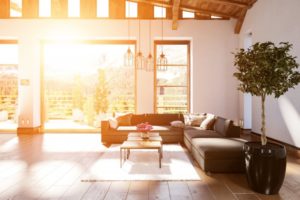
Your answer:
[234,42,300,145]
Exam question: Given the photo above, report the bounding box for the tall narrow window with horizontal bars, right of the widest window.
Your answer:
[155,41,190,113]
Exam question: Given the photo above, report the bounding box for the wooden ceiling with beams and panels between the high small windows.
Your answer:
[0,0,257,34]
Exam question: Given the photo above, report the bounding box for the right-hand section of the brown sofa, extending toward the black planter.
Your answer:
[184,117,246,172]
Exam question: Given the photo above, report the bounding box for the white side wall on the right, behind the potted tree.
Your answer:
[240,0,300,147]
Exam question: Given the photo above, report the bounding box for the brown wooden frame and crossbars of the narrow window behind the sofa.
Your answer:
[153,40,191,113]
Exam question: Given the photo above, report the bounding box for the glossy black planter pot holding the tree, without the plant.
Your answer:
[244,142,286,194]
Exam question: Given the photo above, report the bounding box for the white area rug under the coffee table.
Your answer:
[82,144,201,182]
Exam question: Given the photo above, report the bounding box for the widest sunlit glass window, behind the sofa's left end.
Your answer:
[44,41,135,129]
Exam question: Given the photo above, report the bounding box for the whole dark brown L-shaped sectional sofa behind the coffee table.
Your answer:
[101,114,246,172]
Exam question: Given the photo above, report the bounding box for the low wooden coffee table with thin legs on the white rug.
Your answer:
[120,133,163,168]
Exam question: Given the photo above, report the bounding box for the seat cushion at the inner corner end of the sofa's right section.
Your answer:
[184,127,222,142]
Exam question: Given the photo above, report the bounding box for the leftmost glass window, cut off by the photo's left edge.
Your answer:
[0,40,18,130]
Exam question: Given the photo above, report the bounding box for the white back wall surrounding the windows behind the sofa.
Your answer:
[0,19,238,127]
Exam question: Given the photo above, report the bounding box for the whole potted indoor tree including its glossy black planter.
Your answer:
[234,42,300,194]
